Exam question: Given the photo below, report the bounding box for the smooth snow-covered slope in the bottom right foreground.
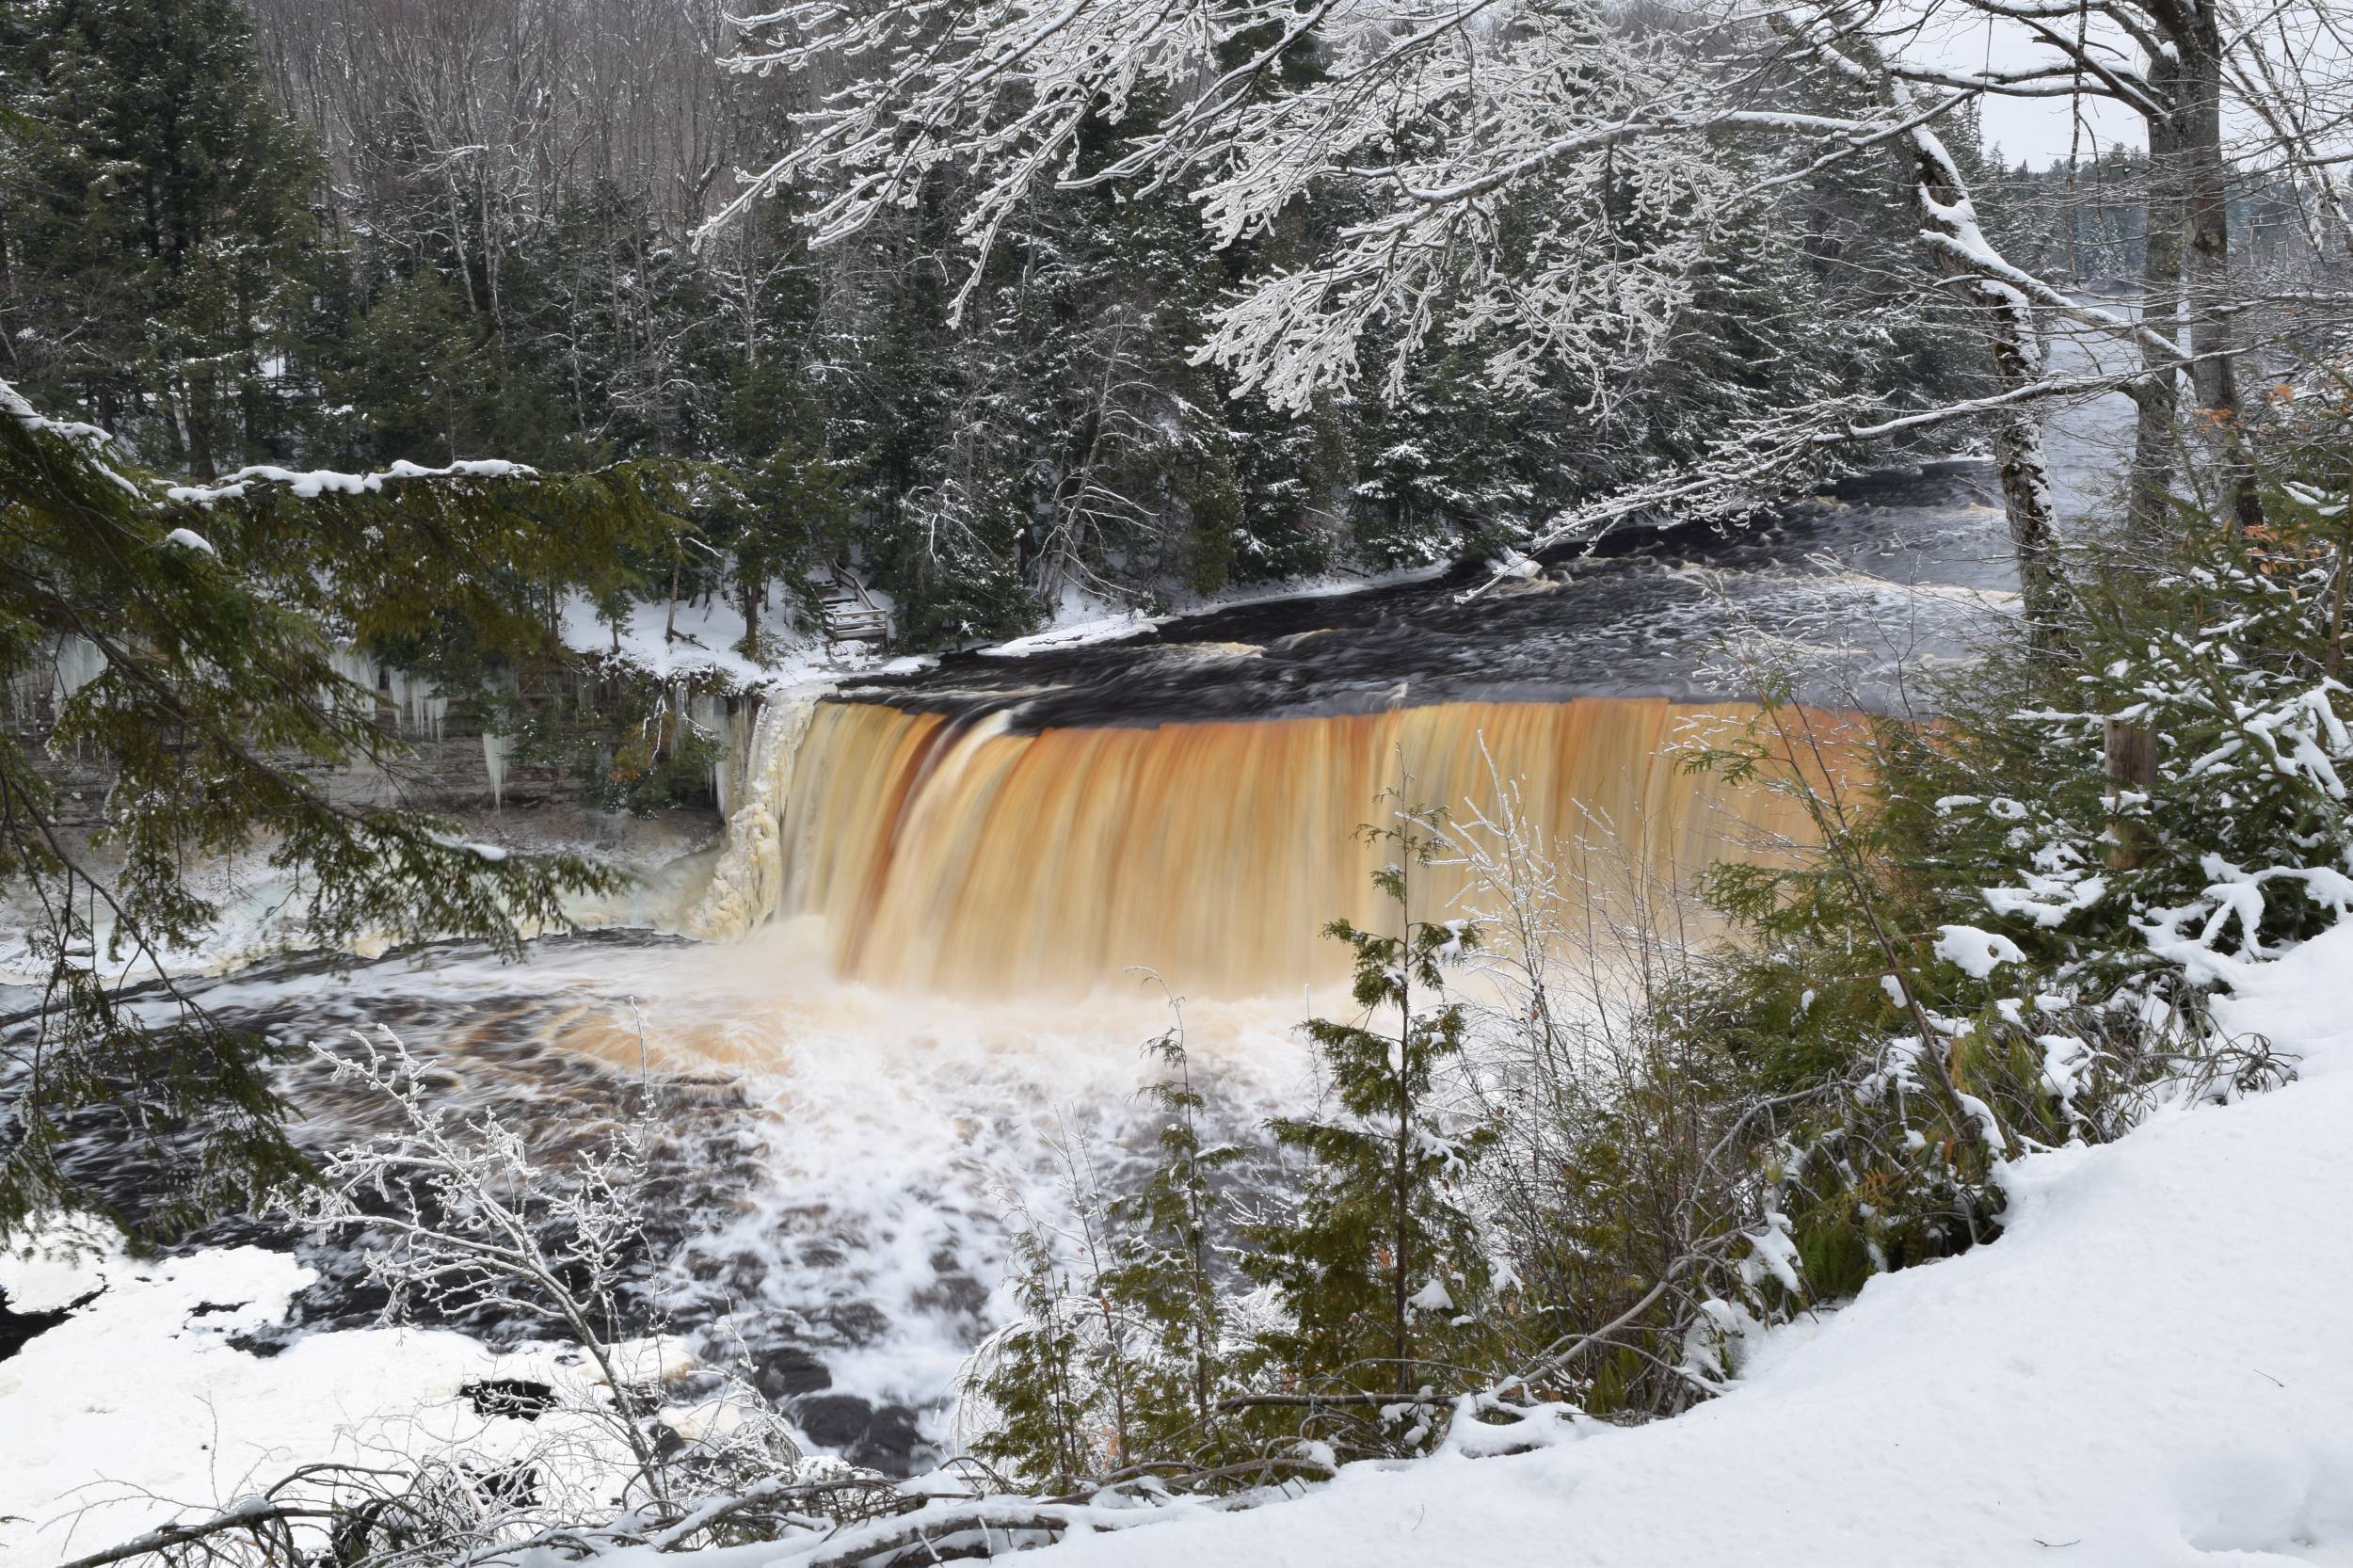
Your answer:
[927,928,2353,1568]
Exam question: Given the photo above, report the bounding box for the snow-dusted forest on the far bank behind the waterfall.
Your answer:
[0,0,2285,645]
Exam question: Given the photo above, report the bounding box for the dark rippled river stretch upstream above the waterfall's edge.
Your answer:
[838,320,2135,729]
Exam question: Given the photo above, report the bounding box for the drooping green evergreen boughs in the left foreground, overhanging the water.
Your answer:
[0,384,680,1239]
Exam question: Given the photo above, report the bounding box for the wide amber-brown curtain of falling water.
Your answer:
[690,696,1845,996]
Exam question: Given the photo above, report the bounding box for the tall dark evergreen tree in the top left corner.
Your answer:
[0,0,323,478]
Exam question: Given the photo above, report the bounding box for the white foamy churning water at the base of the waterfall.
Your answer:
[101,919,1344,1469]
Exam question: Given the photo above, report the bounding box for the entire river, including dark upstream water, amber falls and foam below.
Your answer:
[4,336,2130,1471]
